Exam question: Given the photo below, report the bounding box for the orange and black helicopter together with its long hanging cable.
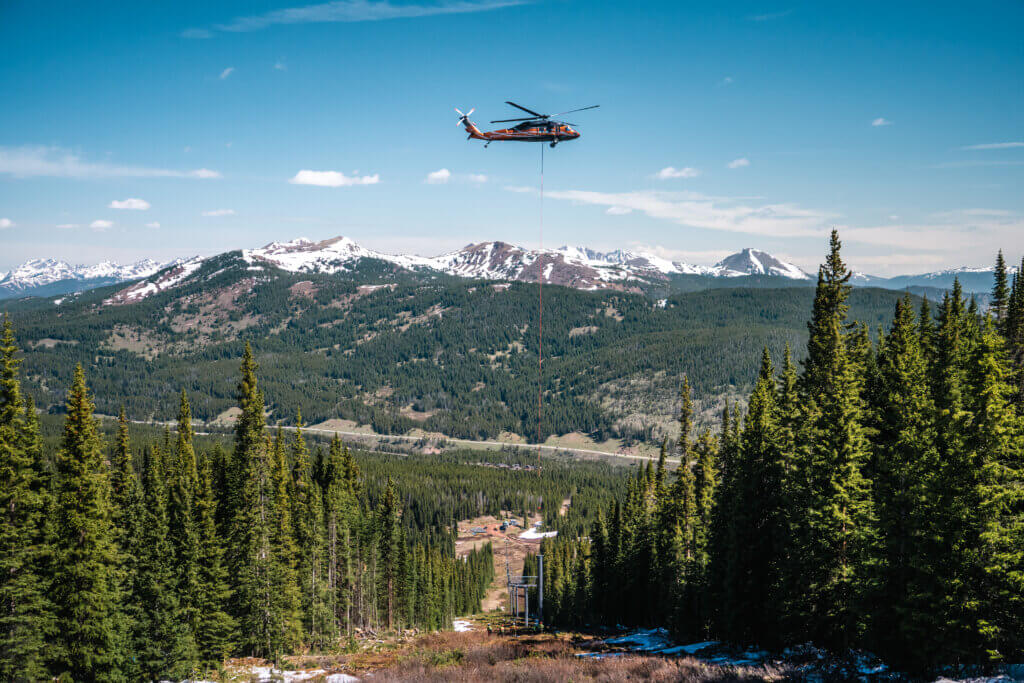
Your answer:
[456,100,600,474]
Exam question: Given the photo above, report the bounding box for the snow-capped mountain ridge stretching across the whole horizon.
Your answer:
[0,236,1003,302]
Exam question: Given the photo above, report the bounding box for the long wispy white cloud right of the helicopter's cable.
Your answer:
[548,190,834,237]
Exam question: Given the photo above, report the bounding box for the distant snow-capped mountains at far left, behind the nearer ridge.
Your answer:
[0,258,167,299]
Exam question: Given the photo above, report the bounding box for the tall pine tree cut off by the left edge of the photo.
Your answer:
[0,315,53,681]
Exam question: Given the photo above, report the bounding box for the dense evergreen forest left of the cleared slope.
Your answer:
[0,318,624,681]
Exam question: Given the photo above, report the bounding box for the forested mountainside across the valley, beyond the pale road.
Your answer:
[0,248,913,442]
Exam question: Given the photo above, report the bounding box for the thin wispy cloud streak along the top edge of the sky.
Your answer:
[181,0,529,38]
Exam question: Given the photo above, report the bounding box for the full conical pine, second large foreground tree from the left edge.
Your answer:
[51,366,126,680]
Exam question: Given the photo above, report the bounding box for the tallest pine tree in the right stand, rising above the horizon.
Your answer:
[786,230,872,647]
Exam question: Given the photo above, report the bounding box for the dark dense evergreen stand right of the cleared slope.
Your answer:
[529,232,1024,675]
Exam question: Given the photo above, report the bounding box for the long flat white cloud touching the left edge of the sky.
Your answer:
[0,145,220,178]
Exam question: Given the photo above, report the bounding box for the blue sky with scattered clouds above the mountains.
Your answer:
[0,0,1024,274]
